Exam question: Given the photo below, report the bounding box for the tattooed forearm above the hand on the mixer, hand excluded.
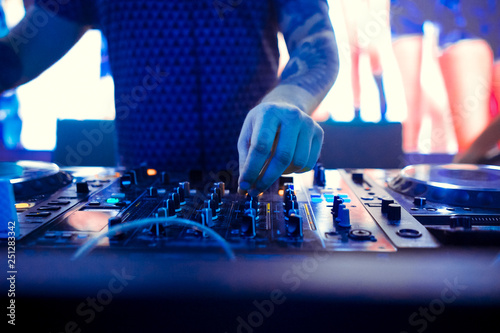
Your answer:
[262,2,339,115]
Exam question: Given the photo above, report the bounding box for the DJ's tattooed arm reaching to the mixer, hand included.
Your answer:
[238,0,338,195]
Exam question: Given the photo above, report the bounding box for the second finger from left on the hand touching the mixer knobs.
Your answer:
[255,125,300,193]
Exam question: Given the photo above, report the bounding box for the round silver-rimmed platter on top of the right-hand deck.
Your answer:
[388,164,500,208]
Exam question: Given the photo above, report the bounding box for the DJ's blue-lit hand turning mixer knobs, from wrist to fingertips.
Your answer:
[238,103,323,196]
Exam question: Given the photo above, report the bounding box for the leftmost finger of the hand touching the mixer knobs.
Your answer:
[240,112,279,189]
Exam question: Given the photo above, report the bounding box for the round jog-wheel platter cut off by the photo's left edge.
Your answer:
[0,161,73,199]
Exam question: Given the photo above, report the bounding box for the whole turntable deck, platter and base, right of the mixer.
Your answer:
[360,164,500,246]
